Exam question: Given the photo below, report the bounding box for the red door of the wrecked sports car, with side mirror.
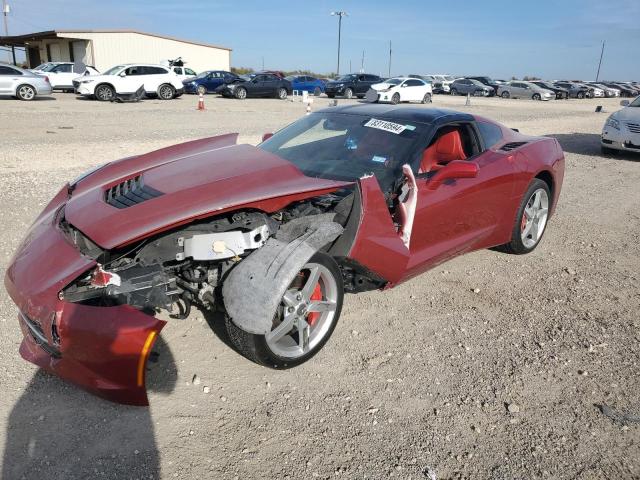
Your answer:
[403,122,514,280]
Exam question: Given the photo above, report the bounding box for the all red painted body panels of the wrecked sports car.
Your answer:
[5,113,564,405]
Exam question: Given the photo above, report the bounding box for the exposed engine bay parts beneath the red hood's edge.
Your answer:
[60,187,384,318]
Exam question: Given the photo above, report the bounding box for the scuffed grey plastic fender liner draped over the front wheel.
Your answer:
[222,222,343,335]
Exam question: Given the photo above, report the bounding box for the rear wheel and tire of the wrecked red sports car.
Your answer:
[500,178,551,255]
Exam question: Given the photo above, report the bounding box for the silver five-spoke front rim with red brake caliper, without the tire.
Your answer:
[265,262,338,360]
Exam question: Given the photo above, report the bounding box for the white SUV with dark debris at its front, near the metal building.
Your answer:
[73,63,184,102]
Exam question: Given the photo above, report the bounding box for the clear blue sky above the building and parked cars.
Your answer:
[2,0,640,80]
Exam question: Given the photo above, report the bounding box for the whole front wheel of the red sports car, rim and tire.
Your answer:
[226,252,344,368]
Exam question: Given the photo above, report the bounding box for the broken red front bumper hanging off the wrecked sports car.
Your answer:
[5,187,165,405]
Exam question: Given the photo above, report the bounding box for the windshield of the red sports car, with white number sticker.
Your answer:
[259,113,429,193]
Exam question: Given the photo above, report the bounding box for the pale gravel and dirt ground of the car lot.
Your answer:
[0,94,640,480]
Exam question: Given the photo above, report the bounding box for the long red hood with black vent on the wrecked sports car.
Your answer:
[64,134,351,250]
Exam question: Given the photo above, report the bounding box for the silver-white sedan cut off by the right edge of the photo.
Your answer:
[600,97,640,154]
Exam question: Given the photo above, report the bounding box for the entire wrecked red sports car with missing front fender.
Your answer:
[5,105,564,405]
